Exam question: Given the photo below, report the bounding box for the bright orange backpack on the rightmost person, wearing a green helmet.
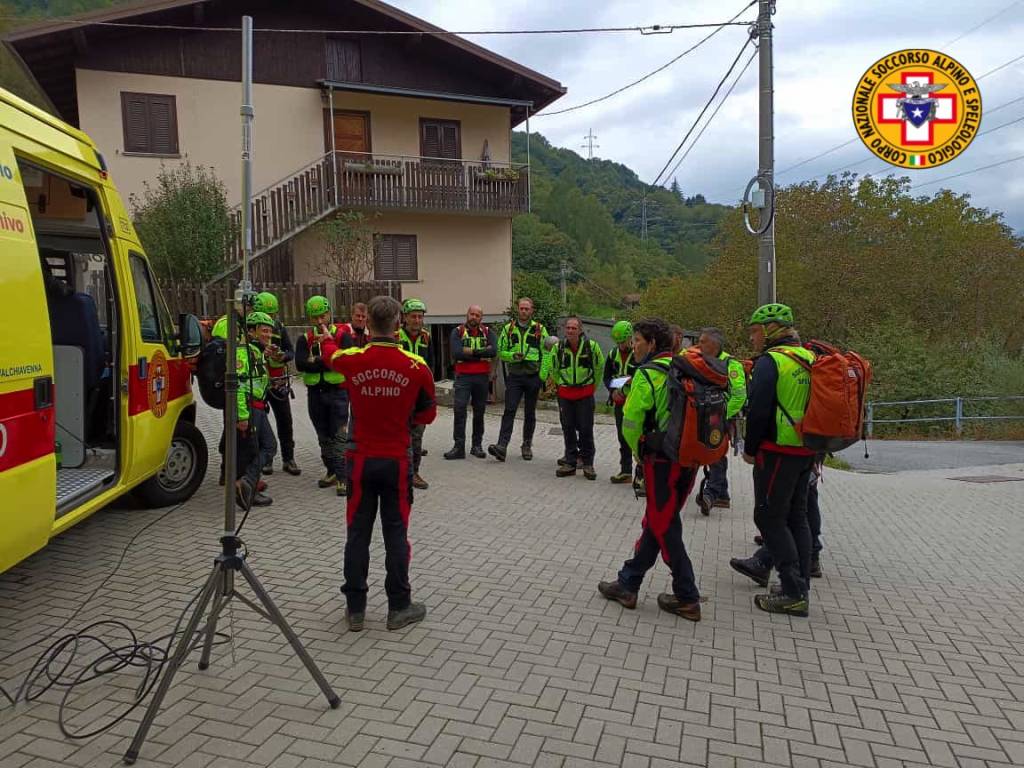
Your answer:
[772,341,871,453]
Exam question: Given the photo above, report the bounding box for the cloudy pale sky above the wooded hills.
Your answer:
[391,0,1024,230]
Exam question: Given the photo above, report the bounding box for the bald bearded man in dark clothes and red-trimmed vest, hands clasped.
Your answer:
[444,305,498,459]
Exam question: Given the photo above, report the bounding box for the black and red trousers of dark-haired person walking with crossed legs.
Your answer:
[618,457,700,603]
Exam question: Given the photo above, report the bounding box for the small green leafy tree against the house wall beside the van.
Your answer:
[129,160,234,281]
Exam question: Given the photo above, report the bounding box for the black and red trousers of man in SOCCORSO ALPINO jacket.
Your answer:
[341,454,413,613]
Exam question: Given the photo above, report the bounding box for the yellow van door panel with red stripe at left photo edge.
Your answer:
[0,162,56,571]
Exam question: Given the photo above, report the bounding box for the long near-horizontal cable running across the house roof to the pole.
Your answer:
[0,16,748,37]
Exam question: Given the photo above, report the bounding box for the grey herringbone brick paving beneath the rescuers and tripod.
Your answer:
[0,400,1024,768]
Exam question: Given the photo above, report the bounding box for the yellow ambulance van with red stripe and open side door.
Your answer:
[0,89,207,571]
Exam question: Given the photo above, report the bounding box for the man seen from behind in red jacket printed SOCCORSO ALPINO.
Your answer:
[321,296,437,632]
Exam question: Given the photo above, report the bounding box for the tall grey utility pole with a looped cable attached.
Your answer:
[758,0,775,304]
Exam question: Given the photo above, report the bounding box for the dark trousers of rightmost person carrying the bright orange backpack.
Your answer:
[754,451,814,597]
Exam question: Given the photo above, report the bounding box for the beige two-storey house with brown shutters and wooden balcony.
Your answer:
[7,0,564,324]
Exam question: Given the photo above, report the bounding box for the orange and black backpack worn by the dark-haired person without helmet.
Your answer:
[639,347,729,468]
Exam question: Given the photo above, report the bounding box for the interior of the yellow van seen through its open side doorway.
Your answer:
[18,161,121,517]
